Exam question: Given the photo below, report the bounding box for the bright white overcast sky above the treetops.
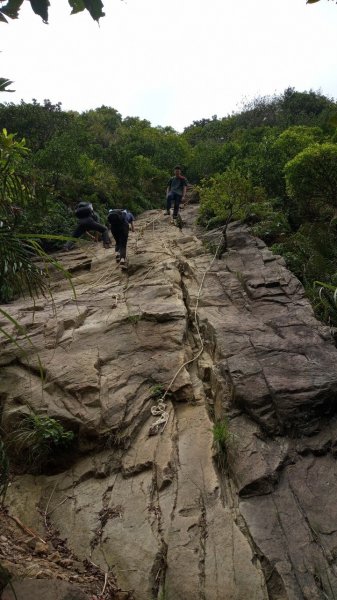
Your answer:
[0,0,337,131]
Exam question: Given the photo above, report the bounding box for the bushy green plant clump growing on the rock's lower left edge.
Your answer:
[6,411,75,472]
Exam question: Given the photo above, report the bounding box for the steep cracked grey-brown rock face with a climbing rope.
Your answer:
[0,207,337,600]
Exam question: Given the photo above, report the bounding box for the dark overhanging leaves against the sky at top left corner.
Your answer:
[0,0,104,23]
